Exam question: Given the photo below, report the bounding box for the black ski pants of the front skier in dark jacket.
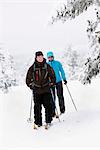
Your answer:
[33,92,52,126]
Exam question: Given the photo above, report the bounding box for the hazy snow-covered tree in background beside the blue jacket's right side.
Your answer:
[62,46,82,80]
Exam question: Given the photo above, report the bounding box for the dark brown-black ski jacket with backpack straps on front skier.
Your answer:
[26,59,56,94]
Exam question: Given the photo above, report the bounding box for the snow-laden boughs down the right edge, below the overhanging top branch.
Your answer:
[81,8,100,84]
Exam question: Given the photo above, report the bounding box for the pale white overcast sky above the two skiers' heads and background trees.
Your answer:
[0,0,96,60]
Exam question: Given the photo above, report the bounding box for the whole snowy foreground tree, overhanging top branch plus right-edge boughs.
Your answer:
[51,0,100,84]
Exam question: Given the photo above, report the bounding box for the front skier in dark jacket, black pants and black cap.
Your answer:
[26,51,56,126]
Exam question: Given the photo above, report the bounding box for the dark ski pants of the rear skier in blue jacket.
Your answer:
[52,81,65,113]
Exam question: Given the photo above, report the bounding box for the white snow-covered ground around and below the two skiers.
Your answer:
[0,79,100,150]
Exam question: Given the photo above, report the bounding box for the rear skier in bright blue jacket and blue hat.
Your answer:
[47,52,67,114]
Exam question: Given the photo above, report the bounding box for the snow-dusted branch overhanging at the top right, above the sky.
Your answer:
[51,0,100,24]
